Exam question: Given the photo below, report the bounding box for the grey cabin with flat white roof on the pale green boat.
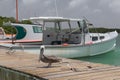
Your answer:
[30,17,91,45]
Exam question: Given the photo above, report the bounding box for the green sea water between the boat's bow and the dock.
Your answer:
[76,34,120,66]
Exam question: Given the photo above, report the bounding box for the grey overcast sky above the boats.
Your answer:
[0,0,120,28]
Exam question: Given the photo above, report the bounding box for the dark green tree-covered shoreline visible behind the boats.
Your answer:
[0,16,120,34]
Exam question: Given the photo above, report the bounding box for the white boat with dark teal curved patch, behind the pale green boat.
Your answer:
[0,23,42,45]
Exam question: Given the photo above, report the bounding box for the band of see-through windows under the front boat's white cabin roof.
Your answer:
[44,21,80,33]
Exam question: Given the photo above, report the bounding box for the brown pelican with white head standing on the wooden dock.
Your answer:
[39,45,61,67]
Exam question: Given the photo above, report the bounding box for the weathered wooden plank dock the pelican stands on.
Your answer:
[0,49,120,80]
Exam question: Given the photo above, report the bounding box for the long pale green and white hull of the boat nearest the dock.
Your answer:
[1,31,118,58]
